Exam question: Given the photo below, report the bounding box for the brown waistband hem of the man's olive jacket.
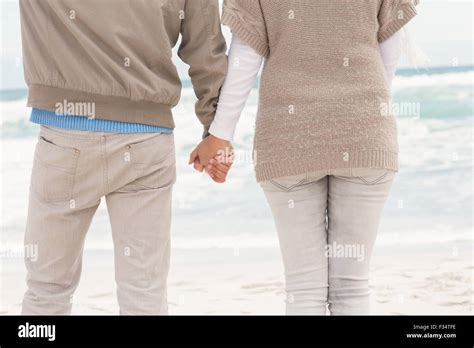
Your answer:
[28,85,175,128]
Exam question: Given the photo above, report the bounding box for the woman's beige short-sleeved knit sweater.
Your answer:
[223,0,418,181]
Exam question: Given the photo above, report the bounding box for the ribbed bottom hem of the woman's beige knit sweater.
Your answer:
[255,150,398,182]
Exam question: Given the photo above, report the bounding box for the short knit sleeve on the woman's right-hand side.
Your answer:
[378,0,419,42]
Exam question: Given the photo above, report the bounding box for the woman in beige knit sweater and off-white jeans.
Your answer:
[191,0,417,314]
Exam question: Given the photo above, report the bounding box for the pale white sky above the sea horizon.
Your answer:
[0,0,474,89]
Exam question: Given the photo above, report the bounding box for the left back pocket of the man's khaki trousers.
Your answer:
[31,136,80,202]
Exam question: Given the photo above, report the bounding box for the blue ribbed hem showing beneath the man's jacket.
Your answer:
[30,109,173,133]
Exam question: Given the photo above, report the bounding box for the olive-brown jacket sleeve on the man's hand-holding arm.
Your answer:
[178,0,227,137]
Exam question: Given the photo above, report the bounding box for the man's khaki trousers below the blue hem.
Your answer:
[22,127,176,314]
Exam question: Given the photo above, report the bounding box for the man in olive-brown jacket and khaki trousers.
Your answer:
[20,0,227,314]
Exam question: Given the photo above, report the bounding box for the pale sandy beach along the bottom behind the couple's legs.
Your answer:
[0,241,473,315]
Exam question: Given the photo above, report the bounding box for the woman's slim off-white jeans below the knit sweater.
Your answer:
[261,169,396,315]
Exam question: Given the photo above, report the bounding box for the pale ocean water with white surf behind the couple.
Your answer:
[0,67,474,251]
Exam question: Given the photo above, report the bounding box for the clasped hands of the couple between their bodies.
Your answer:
[189,135,233,184]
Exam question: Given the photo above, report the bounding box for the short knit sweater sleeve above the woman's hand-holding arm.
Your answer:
[222,0,270,57]
